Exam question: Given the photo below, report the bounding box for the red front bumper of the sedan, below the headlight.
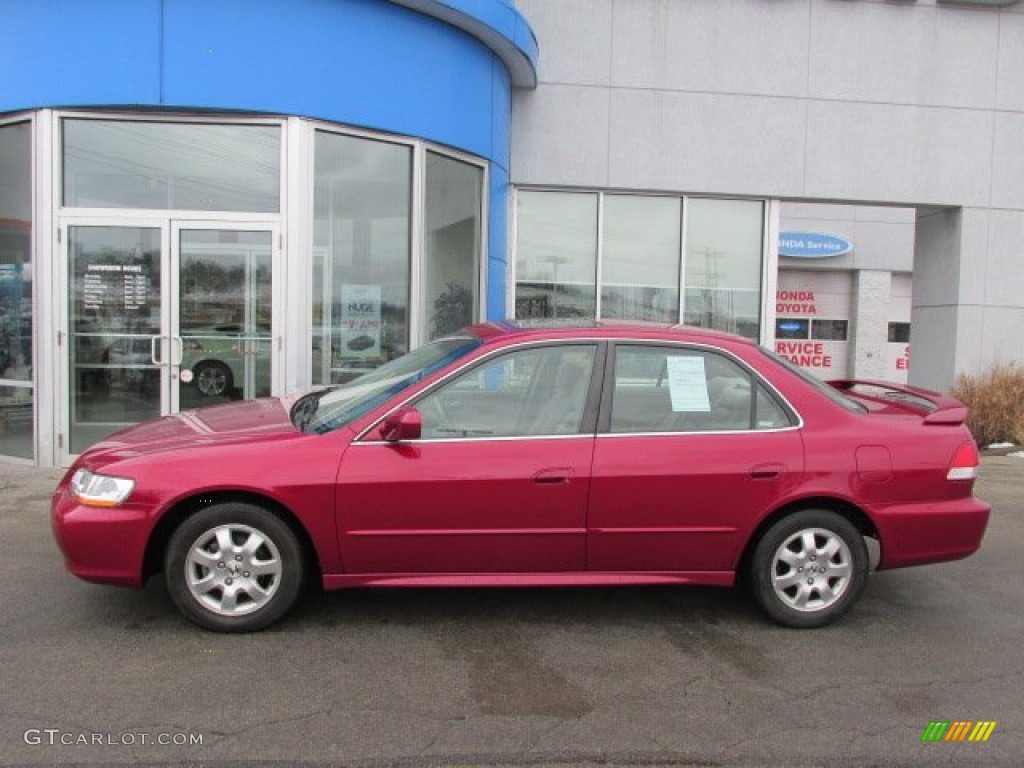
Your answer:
[50,478,153,587]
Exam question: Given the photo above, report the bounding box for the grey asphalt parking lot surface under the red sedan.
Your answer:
[0,457,1024,768]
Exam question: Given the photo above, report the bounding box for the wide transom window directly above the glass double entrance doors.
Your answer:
[62,119,281,213]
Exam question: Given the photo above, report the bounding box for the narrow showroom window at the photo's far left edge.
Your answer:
[0,123,35,459]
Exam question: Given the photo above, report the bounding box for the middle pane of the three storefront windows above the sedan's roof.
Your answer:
[601,195,682,323]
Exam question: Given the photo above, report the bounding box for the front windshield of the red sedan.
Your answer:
[291,336,482,434]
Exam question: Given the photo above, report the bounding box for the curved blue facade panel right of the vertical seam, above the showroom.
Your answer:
[164,0,509,158]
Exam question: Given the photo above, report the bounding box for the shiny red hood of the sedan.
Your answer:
[83,397,303,463]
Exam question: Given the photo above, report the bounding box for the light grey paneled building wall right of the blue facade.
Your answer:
[511,0,1024,388]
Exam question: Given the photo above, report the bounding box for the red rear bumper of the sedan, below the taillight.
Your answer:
[873,497,991,570]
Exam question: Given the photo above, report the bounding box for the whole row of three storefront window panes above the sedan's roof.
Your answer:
[515,189,764,339]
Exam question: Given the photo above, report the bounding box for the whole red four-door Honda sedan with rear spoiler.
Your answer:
[52,324,989,632]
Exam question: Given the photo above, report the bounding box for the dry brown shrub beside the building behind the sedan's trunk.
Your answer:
[951,362,1024,447]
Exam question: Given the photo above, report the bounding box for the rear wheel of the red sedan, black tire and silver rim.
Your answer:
[748,509,868,629]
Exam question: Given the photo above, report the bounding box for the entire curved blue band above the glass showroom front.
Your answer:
[0,0,521,165]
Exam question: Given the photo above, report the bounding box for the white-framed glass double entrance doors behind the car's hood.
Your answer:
[65,220,279,461]
